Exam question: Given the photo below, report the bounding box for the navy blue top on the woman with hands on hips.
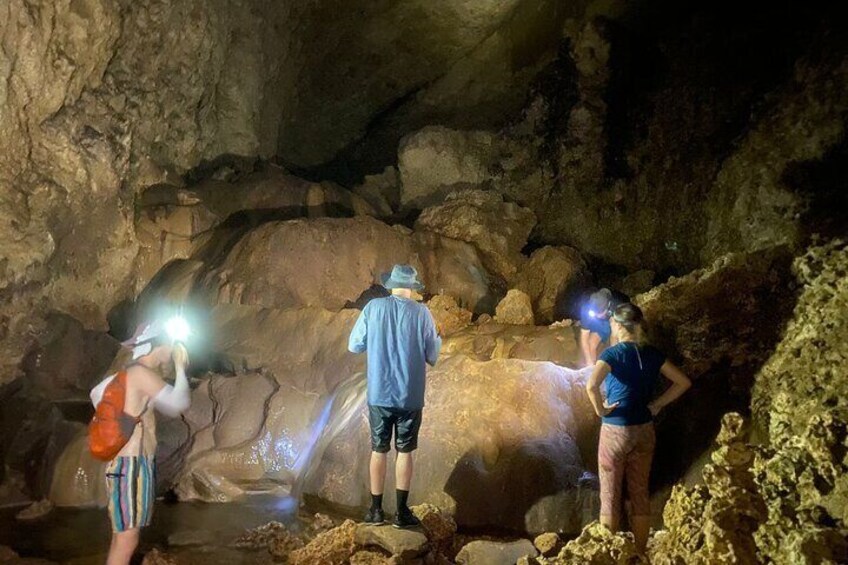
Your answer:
[599,341,665,426]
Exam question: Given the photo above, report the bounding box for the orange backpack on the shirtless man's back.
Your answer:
[88,371,147,461]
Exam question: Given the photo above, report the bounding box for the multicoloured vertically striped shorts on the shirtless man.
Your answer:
[106,455,156,532]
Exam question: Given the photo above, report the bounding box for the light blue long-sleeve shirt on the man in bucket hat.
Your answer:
[348,296,442,410]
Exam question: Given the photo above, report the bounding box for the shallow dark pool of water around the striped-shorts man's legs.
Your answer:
[0,496,302,565]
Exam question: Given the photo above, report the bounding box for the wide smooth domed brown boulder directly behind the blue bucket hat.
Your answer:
[180,217,495,312]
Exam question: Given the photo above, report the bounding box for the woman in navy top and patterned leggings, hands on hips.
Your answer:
[586,304,692,553]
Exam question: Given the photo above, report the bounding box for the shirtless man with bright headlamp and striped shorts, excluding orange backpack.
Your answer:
[91,322,191,565]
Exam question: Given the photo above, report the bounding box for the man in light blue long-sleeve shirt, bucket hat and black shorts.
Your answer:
[348,265,442,528]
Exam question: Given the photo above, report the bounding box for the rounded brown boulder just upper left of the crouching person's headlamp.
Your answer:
[515,246,591,324]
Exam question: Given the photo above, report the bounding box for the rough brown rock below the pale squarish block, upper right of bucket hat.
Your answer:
[415,190,536,281]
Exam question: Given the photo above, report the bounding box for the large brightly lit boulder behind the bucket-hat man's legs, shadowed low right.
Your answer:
[304,356,598,532]
